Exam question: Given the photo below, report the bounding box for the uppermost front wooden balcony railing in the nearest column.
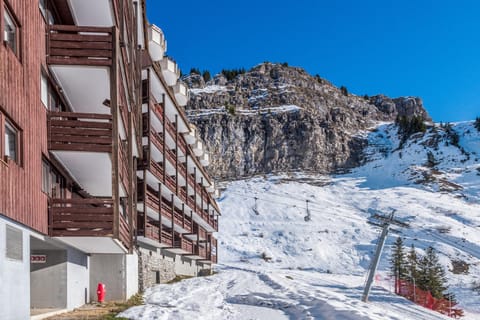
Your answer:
[47,25,115,67]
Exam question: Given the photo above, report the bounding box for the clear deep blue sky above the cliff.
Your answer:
[147,0,480,122]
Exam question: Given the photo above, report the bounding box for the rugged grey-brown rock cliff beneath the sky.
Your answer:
[184,63,430,179]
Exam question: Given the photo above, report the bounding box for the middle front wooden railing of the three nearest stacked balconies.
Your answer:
[48,112,113,153]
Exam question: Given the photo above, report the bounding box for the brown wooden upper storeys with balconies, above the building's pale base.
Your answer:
[0,0,220,263]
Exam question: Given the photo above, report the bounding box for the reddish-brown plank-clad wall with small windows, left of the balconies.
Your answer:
[0,0,48,234]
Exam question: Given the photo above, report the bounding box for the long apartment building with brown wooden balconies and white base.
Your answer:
[0,0,220,319]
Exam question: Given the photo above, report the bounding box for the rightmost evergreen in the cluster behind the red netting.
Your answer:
[417,247,447,299]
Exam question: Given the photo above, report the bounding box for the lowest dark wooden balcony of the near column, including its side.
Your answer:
[49,198,130,248]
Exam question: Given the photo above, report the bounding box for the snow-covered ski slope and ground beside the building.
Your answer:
[122,123,480,320]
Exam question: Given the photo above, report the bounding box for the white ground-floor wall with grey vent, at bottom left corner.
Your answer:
[0,216,30,320]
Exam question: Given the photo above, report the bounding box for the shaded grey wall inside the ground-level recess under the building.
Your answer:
[30,250,67,309]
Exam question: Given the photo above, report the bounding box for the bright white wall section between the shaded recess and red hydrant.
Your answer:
[67,249,90,309]
